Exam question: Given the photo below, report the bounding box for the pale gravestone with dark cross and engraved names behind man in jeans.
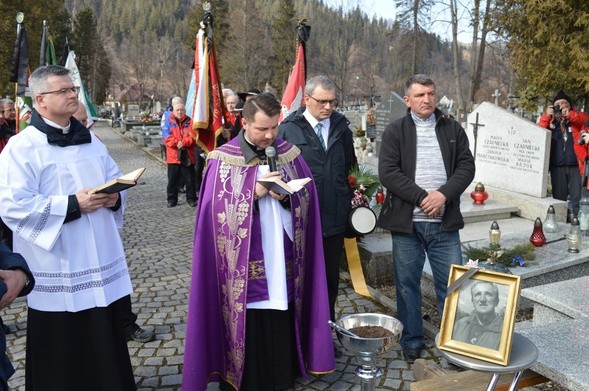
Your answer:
[466,102,550,197]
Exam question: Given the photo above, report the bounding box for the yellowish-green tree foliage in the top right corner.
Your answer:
[493,0,589,109]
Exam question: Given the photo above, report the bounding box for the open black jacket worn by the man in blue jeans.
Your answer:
[377,110,475,233]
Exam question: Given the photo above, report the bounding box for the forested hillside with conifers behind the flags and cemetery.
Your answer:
[0,0,464,107]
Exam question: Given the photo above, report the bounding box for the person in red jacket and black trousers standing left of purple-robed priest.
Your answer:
[164,103,197,208]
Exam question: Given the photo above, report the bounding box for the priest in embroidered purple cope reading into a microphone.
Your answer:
[182,94,335,391]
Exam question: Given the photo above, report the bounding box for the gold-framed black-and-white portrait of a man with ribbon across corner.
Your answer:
[438,265,521,365]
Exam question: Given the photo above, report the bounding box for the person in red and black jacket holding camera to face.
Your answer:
[538,91,589,221]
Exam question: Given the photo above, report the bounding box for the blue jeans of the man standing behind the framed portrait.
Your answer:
[391,222,462,348]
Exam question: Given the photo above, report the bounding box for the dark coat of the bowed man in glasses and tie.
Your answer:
[278,108,356,236]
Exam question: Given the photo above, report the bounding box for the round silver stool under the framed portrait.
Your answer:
[436,333,538,391]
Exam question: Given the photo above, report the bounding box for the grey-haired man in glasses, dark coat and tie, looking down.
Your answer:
[278,76,356,334]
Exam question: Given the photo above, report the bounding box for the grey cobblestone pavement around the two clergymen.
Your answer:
[0,122,439,391]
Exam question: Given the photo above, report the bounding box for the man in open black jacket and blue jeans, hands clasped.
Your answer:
[378,75,475,362]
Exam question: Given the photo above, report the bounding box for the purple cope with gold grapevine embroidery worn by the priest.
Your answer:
[182,137,335,391]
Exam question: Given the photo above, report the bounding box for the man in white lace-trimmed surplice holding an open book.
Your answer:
[0,65,136,391]
